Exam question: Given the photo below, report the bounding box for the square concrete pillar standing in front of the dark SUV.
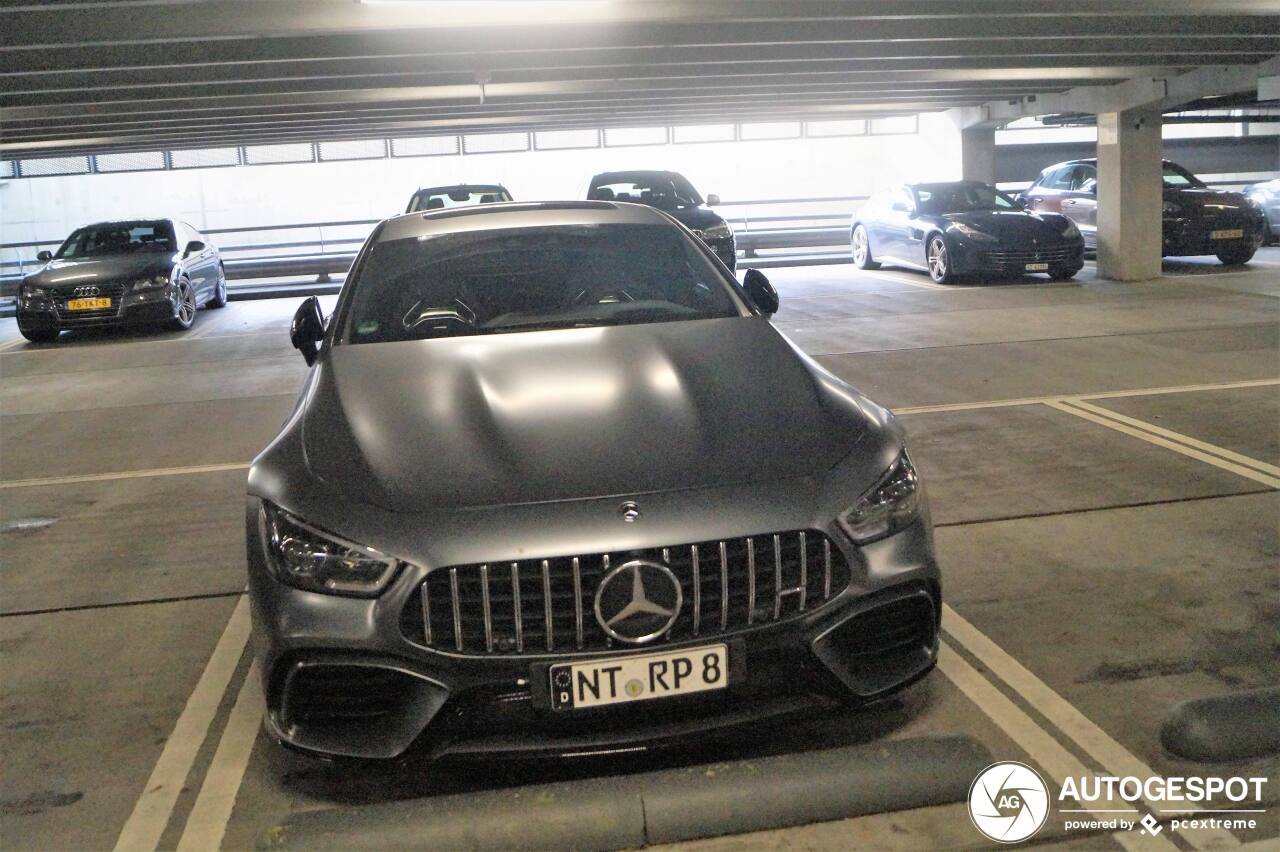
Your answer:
[1098,109,1164,281]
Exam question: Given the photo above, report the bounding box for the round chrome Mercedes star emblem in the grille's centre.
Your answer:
[595,559,684,645]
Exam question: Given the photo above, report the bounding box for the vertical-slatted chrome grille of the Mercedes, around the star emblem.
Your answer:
[401,530,849,655]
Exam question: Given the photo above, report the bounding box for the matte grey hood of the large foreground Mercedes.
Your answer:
[302,317,868,512]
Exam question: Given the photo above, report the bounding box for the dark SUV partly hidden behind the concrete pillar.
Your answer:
[1021,160,1263,264]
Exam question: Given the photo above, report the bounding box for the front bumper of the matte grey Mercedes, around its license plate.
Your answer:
[247,499,941,759]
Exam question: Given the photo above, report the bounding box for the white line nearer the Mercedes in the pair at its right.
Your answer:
[938,639,1172,852]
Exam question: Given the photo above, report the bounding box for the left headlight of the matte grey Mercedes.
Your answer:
[259,504,399,597]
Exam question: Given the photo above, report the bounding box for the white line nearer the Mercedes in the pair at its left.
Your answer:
[178,661,265,852]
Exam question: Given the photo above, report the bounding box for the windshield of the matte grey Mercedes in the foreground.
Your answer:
[339,224,741,343]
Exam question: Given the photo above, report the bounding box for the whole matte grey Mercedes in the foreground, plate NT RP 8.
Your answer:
[246,201,940,759]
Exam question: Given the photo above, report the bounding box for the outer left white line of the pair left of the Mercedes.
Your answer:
[115,597,250,852]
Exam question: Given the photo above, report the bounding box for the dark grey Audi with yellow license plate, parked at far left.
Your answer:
[17,219,227,343]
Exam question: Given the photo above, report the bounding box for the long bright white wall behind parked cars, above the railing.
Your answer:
[0,114,959,243]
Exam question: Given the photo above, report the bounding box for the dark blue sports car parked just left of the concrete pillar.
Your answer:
[850,180,1084,284]
